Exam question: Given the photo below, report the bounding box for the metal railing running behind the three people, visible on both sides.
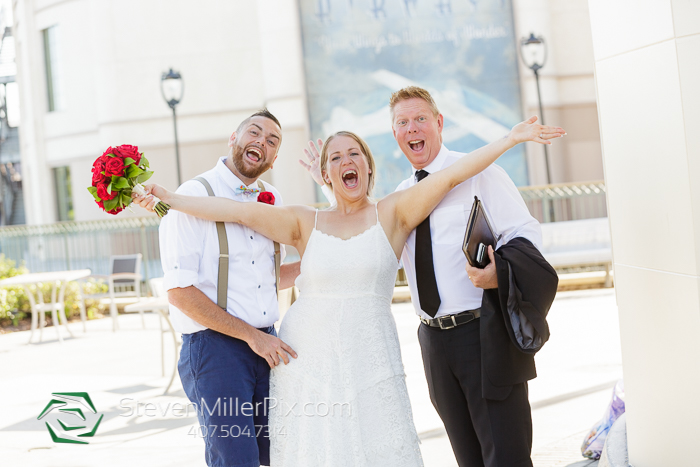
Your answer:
[0,181,607,283]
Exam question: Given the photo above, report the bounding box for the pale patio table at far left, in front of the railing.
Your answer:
[0,269,92,344]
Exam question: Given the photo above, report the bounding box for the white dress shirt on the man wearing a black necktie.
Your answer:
[396,146,542,319]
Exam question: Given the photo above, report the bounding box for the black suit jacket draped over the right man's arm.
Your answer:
[480,237,559,400]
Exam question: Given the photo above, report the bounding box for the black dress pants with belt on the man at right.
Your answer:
[418,319,532,467]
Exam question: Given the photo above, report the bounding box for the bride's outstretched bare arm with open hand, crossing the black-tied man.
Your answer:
[387,117,565,233]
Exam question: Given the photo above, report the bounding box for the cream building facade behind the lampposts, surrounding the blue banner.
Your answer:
[12,0,603,224]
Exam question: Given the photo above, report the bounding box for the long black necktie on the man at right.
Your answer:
[415,170,440,318]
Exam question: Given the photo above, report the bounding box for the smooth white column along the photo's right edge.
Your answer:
[589,0,700,467]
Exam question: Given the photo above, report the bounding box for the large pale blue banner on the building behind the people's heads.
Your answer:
[299,0,528,197]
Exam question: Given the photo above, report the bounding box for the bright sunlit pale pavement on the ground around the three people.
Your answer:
[0,289,622,467]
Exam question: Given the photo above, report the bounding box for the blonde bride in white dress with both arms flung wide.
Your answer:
[135,117,563,467]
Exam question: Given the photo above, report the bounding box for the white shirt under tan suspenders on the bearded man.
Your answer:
[159,157,284,334]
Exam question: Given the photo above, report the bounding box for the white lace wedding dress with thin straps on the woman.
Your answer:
[269,208,423,467]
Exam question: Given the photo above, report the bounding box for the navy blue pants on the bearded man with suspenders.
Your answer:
[178,327,277,467]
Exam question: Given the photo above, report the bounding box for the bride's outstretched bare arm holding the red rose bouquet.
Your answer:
[132,185,311,247]
